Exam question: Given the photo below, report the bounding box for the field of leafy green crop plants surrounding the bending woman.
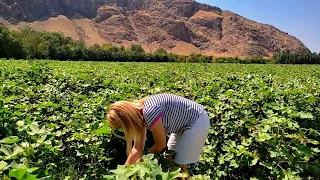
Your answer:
[0,60,320,179]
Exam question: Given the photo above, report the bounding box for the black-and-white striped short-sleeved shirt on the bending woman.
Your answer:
[143,94,204,134]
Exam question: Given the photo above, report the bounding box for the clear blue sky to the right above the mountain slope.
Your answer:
[196,0,320,52]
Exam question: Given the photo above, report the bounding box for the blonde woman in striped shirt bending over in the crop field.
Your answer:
[107,94,210,172]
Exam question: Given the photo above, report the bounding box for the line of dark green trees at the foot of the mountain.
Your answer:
[0,26,320,64]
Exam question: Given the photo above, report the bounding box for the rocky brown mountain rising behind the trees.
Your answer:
[0,0,308,57]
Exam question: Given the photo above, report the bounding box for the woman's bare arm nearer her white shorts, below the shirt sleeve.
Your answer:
[149,118,167,154]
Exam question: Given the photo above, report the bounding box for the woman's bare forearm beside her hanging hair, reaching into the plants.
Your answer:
[125,129,146,165]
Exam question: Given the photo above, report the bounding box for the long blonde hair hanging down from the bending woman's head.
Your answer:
[107,101,146,155]
